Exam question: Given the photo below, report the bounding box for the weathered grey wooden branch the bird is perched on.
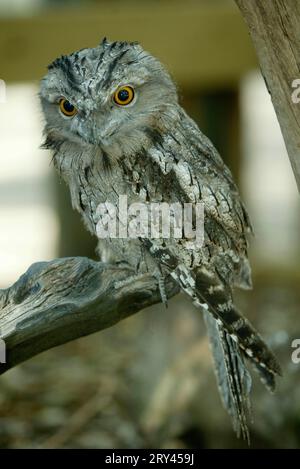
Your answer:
[0,257,178,374]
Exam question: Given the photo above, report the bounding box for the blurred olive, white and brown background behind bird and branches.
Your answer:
[0,0,300,448]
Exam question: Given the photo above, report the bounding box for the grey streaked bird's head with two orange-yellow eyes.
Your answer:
[40,39,178,157]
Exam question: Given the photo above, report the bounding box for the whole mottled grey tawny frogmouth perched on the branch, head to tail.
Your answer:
[40,38,281,441]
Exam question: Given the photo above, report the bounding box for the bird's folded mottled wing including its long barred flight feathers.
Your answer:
[143,119,281,389]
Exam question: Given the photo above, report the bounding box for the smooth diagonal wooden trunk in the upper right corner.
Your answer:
[235,0,300,191]
